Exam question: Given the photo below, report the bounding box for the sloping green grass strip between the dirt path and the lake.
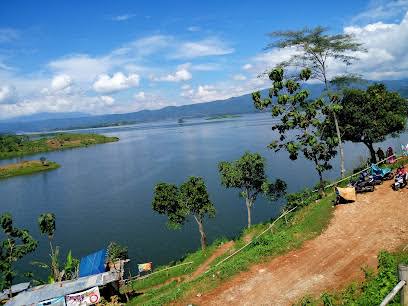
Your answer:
[129,193,334,305]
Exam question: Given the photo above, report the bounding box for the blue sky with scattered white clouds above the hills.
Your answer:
[0,0,408,119]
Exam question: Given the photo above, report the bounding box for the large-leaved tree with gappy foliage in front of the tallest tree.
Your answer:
[252,67,338,196]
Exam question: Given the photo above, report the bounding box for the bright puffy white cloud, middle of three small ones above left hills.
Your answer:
[93,72,140,93]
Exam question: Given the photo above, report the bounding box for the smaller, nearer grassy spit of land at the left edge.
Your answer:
[0,160,60,179]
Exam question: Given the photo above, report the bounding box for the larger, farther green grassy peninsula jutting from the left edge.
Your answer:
[0,133,119,159]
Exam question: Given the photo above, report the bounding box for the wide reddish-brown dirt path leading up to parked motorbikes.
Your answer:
[189,181,408,305]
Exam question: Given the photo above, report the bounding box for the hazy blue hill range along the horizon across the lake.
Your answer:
[0,79,408,133]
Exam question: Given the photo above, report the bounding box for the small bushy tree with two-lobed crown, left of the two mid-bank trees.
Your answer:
[152,176,215,250]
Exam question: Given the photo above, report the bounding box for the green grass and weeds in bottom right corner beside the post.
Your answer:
[297,250,408,306]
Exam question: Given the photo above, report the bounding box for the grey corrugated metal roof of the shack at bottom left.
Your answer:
[5,271,120,306]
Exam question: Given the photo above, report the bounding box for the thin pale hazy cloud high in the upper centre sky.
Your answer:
[173,38,234,58]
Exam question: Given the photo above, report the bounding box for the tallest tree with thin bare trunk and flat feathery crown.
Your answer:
[267,26,365,177]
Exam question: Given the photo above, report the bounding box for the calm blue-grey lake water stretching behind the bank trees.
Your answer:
[0,114,408,276]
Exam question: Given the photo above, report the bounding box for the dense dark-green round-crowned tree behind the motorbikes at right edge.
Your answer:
[329,84,408,163]
